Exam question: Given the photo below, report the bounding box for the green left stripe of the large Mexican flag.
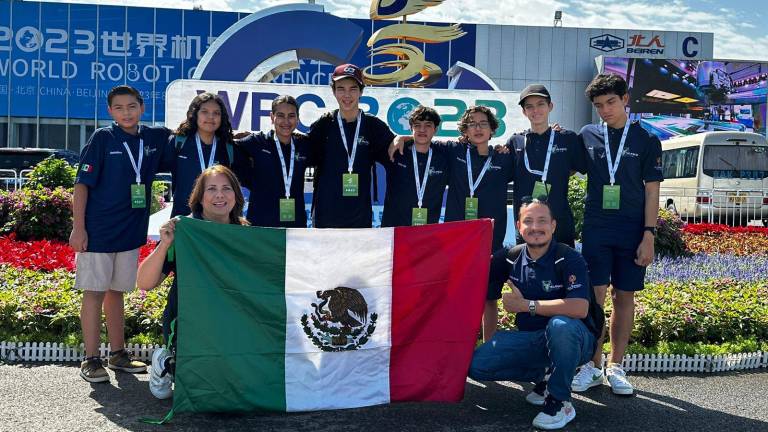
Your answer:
[173,218,286,413]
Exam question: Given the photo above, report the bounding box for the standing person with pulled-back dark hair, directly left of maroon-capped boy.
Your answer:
[234,96,309,228]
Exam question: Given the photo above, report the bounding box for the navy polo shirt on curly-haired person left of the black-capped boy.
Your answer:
[445,141,514,250]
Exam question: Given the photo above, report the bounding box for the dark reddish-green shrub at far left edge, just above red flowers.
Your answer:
[3,187,72,241]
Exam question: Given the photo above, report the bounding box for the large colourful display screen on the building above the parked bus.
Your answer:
[603,57,768,139]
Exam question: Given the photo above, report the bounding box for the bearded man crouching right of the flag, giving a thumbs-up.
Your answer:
[469,199,597,429]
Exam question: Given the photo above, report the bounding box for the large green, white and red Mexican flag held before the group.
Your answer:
[173,218,492,413]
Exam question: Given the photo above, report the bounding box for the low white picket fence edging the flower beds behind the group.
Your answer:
[0,342,768,373]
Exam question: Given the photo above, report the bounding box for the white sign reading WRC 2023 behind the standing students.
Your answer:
[165,80,528,142]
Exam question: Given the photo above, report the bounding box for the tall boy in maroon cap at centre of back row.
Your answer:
[309,64,395,228]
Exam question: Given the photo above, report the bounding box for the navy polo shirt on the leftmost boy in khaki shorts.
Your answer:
[75,124,173,253]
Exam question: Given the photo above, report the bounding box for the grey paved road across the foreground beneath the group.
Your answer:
[0,364,768,432]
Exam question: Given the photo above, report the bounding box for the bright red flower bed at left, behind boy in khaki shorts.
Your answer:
[0,234,157,271]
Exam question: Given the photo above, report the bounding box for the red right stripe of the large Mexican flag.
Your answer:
[389,219,493,402]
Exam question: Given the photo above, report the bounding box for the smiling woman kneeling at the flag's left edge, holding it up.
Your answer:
[136,165,248,399]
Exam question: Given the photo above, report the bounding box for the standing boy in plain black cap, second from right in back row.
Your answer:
[507,84,585,247]
